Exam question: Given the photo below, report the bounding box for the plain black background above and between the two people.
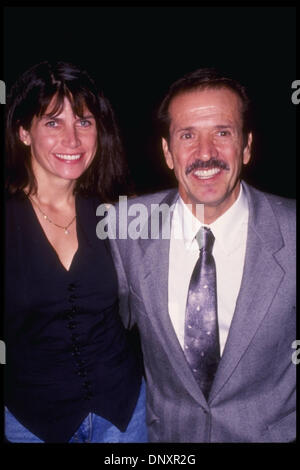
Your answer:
[4,6,299,197]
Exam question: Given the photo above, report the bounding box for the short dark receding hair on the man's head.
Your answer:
[157,68,252,143]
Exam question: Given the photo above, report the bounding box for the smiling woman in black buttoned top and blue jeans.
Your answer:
[5,62,146,442]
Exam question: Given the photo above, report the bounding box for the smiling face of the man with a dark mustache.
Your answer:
[163,88,252,219]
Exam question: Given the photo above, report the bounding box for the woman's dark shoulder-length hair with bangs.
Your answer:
[6,61,131,202]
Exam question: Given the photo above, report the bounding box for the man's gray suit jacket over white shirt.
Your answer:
[111,183,296,442]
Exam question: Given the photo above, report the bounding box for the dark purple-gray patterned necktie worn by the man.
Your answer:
[184,227,220,399]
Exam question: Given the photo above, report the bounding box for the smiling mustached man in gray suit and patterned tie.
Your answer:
[106,69,296,442]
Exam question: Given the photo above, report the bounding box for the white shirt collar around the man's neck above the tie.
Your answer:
[173,184,249,254]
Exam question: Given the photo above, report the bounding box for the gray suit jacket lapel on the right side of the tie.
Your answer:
[210,184,284,401]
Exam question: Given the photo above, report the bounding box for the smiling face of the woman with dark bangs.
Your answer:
[19,97,97,181]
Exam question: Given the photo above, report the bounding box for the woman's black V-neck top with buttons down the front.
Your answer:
[4,196,141,442]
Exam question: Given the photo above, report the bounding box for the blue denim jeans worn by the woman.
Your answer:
[5,382,148,443]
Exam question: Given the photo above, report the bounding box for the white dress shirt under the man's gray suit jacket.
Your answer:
[168,185,249,354]
